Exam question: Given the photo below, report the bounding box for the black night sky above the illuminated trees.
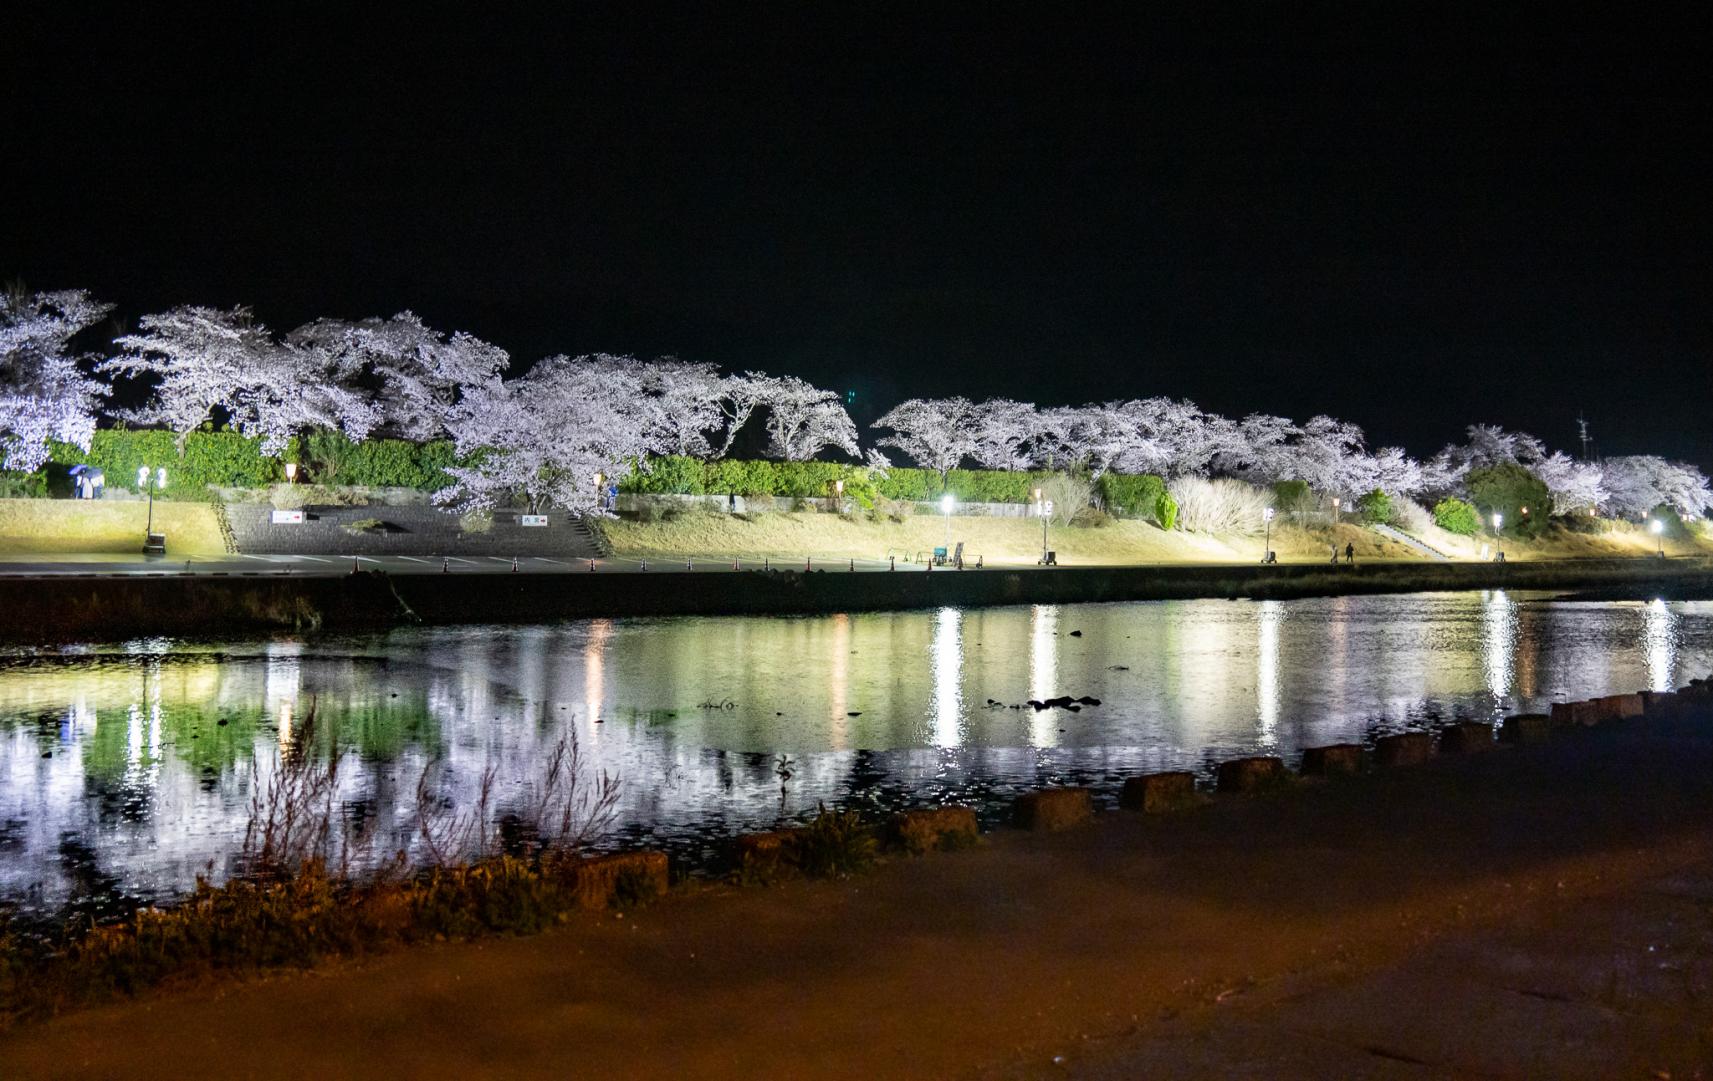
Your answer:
[0,3,1713,468]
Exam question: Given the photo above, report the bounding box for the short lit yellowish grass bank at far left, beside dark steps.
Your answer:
[0,499,226,558]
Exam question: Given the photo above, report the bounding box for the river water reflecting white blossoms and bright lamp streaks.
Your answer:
[0,593,1713,910]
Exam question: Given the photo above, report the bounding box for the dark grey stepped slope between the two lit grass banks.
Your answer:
[224,504,608,560]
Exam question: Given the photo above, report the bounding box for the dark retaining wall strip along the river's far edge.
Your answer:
[0,558,1713,644]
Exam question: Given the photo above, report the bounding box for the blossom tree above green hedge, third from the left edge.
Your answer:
[286,312,510,442]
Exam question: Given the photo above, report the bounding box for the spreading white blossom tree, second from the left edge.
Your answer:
[99,305,375,454]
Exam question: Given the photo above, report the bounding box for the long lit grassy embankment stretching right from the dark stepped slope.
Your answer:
[603,511,1713,565]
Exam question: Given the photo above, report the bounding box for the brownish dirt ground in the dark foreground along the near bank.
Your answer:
[0,726,1713,1081]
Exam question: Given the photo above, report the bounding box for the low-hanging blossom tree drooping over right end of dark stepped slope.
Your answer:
[433,355,666,514]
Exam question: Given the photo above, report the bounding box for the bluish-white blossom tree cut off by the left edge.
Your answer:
[0,290,113,471]
